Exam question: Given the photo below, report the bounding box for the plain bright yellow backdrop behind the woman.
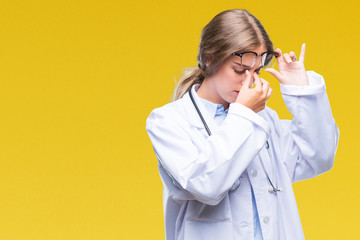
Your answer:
[0,0,360,240]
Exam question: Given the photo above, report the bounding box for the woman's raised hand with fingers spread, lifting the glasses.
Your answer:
[265,43,309,86]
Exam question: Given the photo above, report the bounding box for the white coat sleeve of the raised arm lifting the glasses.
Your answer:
[277,71,339,182]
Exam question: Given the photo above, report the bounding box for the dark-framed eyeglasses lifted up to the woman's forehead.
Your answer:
[231,51,279,69]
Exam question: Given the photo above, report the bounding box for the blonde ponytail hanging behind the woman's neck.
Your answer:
[172,66,205,101]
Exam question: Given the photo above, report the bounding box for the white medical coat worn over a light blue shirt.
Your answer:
[146,71,339,240]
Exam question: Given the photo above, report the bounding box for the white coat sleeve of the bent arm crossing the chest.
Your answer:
[146,103,270,205]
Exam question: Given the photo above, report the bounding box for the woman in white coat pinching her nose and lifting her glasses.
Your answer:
[146,9,339,240]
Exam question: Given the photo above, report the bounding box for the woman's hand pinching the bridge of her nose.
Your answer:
[235,70,272,112]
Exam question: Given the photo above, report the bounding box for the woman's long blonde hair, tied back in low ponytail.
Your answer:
[173,9,274,101]
